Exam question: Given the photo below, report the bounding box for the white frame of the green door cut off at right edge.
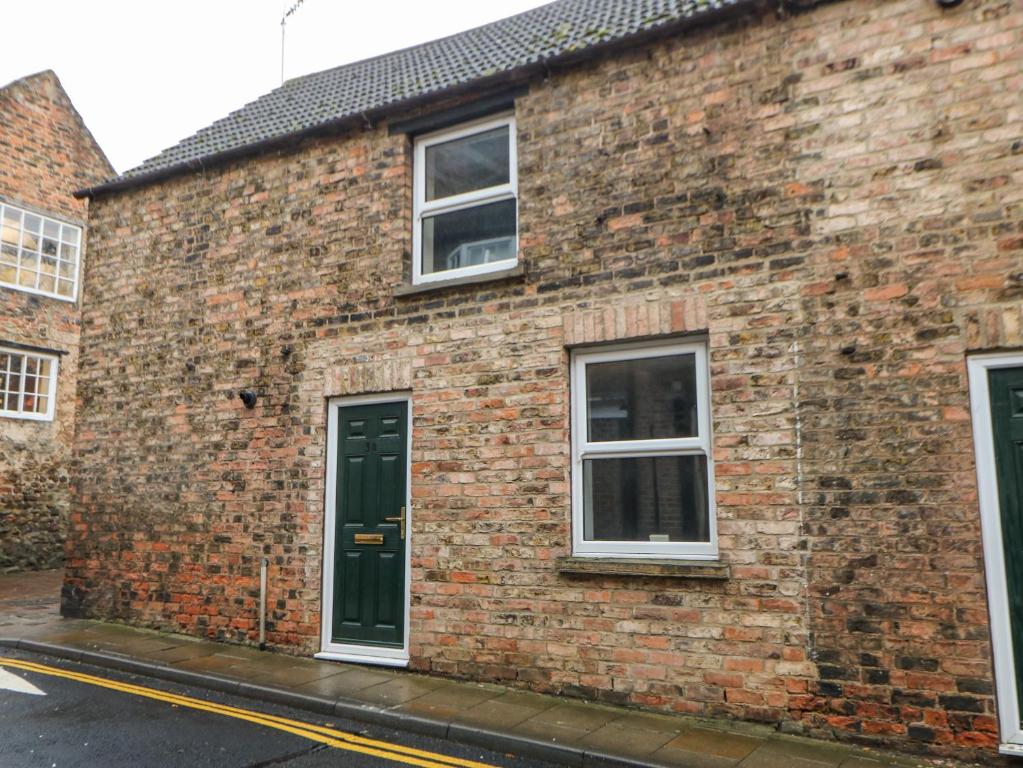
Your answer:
[967,352,1023,755]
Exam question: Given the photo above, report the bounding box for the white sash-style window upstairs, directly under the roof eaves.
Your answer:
[412,115,519,284]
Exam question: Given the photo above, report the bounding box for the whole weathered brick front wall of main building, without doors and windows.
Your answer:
[63,0,1023,757]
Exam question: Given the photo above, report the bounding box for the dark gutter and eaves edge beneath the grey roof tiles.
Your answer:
[74,0,770,199]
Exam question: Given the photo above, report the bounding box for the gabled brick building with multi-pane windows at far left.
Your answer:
[0,72,113,571]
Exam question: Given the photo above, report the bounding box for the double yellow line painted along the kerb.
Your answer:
[0,657,493,768]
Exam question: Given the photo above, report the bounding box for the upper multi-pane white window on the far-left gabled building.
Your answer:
[0,205,82,302]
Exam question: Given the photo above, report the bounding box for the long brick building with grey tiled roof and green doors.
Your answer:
[63,0,1023,757]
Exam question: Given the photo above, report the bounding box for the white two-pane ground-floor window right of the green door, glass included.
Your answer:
[572,342,717,559]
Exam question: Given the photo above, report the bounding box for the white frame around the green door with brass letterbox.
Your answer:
[315,392,412,667]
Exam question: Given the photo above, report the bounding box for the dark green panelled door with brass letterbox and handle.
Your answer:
[331,402,408,647]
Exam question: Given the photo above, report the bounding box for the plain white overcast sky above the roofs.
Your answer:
[0,0,545,171]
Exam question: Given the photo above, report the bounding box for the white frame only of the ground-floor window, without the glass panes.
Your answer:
[571,341,718,560]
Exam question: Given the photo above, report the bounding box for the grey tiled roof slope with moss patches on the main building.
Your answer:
[96,0,746,190]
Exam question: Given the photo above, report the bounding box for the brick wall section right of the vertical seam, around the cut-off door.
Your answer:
[780,2,1023,749]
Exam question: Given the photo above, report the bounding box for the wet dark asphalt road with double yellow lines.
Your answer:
[0,650,549,768]
